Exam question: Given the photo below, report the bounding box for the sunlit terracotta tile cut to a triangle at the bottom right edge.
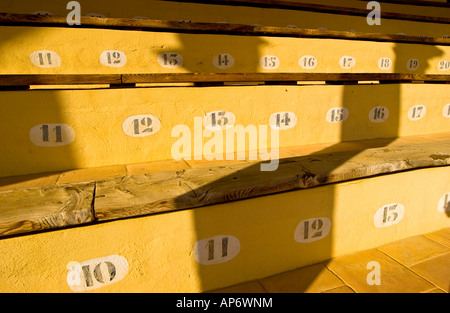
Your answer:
[411,253,450,292]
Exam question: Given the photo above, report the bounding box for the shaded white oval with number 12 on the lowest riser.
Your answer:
[294,217,331,243]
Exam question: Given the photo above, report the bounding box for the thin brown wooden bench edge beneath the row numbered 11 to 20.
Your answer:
[0,73,450,87]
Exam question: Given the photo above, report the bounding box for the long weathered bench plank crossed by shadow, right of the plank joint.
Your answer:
[95,140,450,221]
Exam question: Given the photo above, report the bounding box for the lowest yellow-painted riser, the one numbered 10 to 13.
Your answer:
[0,167,450,292]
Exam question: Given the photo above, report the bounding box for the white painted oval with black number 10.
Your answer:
[67,255,128,292]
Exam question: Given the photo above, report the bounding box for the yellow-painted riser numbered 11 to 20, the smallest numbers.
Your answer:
[0,26,450,74]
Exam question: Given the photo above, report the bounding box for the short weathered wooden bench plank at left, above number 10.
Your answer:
[0,183,95,237]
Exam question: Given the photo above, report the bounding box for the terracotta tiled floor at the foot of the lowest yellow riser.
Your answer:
[212,228,450,293]
